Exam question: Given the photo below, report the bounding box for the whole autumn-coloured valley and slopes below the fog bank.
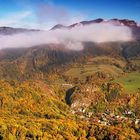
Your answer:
[0,38,140,140]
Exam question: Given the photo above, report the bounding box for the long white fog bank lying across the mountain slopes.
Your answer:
[0,23,133,50]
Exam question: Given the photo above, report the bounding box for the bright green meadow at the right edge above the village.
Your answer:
[115,72,140,92]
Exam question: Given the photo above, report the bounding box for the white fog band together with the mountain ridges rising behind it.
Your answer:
[0,19,140,50]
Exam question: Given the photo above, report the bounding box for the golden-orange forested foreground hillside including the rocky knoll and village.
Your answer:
[0,77,140,139]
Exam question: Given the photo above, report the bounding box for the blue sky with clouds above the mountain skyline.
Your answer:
[0,0,140,29]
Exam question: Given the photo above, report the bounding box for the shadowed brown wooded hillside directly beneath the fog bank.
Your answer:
[0,41,140,80]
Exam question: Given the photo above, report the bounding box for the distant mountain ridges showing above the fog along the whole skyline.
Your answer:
[0,18,140,39]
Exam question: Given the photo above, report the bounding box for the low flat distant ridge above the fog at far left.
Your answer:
[0,27,39,35]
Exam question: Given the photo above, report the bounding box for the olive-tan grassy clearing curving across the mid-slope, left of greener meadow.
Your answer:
[65,56,125,79]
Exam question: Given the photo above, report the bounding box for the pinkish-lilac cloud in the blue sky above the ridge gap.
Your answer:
[33,2,86,27]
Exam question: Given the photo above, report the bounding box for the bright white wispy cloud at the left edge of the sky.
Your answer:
[0,11,31,26]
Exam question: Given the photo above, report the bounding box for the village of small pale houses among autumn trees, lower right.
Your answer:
[71,106,140,126]
